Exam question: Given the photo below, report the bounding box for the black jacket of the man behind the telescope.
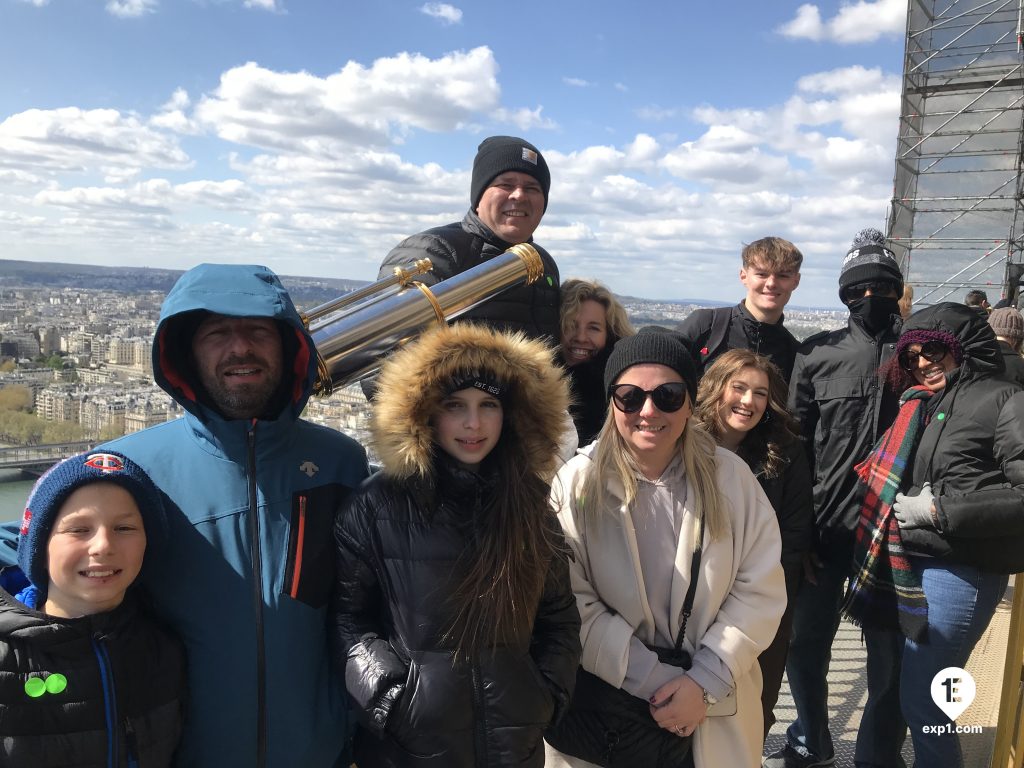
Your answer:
[379,211,560,341]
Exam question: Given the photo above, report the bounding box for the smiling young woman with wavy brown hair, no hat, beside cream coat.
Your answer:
[693,349,814,736]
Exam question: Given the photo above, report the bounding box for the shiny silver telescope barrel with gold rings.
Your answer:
[311,243,544,393]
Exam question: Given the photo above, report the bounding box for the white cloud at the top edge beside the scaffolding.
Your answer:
[776,0,906,44]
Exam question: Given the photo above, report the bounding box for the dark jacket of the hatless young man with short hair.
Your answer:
[679,301,800,382]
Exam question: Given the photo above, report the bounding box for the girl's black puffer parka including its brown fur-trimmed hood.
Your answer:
[333,324,581,768]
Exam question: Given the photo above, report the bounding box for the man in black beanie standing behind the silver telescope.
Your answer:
[379,136,560,343]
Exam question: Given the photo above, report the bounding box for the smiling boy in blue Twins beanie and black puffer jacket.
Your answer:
[0,452,184,768]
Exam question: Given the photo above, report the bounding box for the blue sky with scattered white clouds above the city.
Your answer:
[0,0,906,306]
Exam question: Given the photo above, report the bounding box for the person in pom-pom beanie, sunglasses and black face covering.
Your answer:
[764,229,906,768]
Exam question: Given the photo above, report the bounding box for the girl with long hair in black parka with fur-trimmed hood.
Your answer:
[332,324,581,768]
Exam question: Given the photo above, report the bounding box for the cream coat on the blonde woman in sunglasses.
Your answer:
[552,447,785,768]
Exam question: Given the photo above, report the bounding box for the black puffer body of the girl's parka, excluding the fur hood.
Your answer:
[333,462,581,768]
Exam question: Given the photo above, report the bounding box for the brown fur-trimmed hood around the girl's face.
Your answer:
[371,323,569,482]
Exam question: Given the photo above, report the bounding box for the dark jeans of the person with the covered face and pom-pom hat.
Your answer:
[785,540,906,768]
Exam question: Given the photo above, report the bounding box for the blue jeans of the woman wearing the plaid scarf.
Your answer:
[900,557,1009,768]
